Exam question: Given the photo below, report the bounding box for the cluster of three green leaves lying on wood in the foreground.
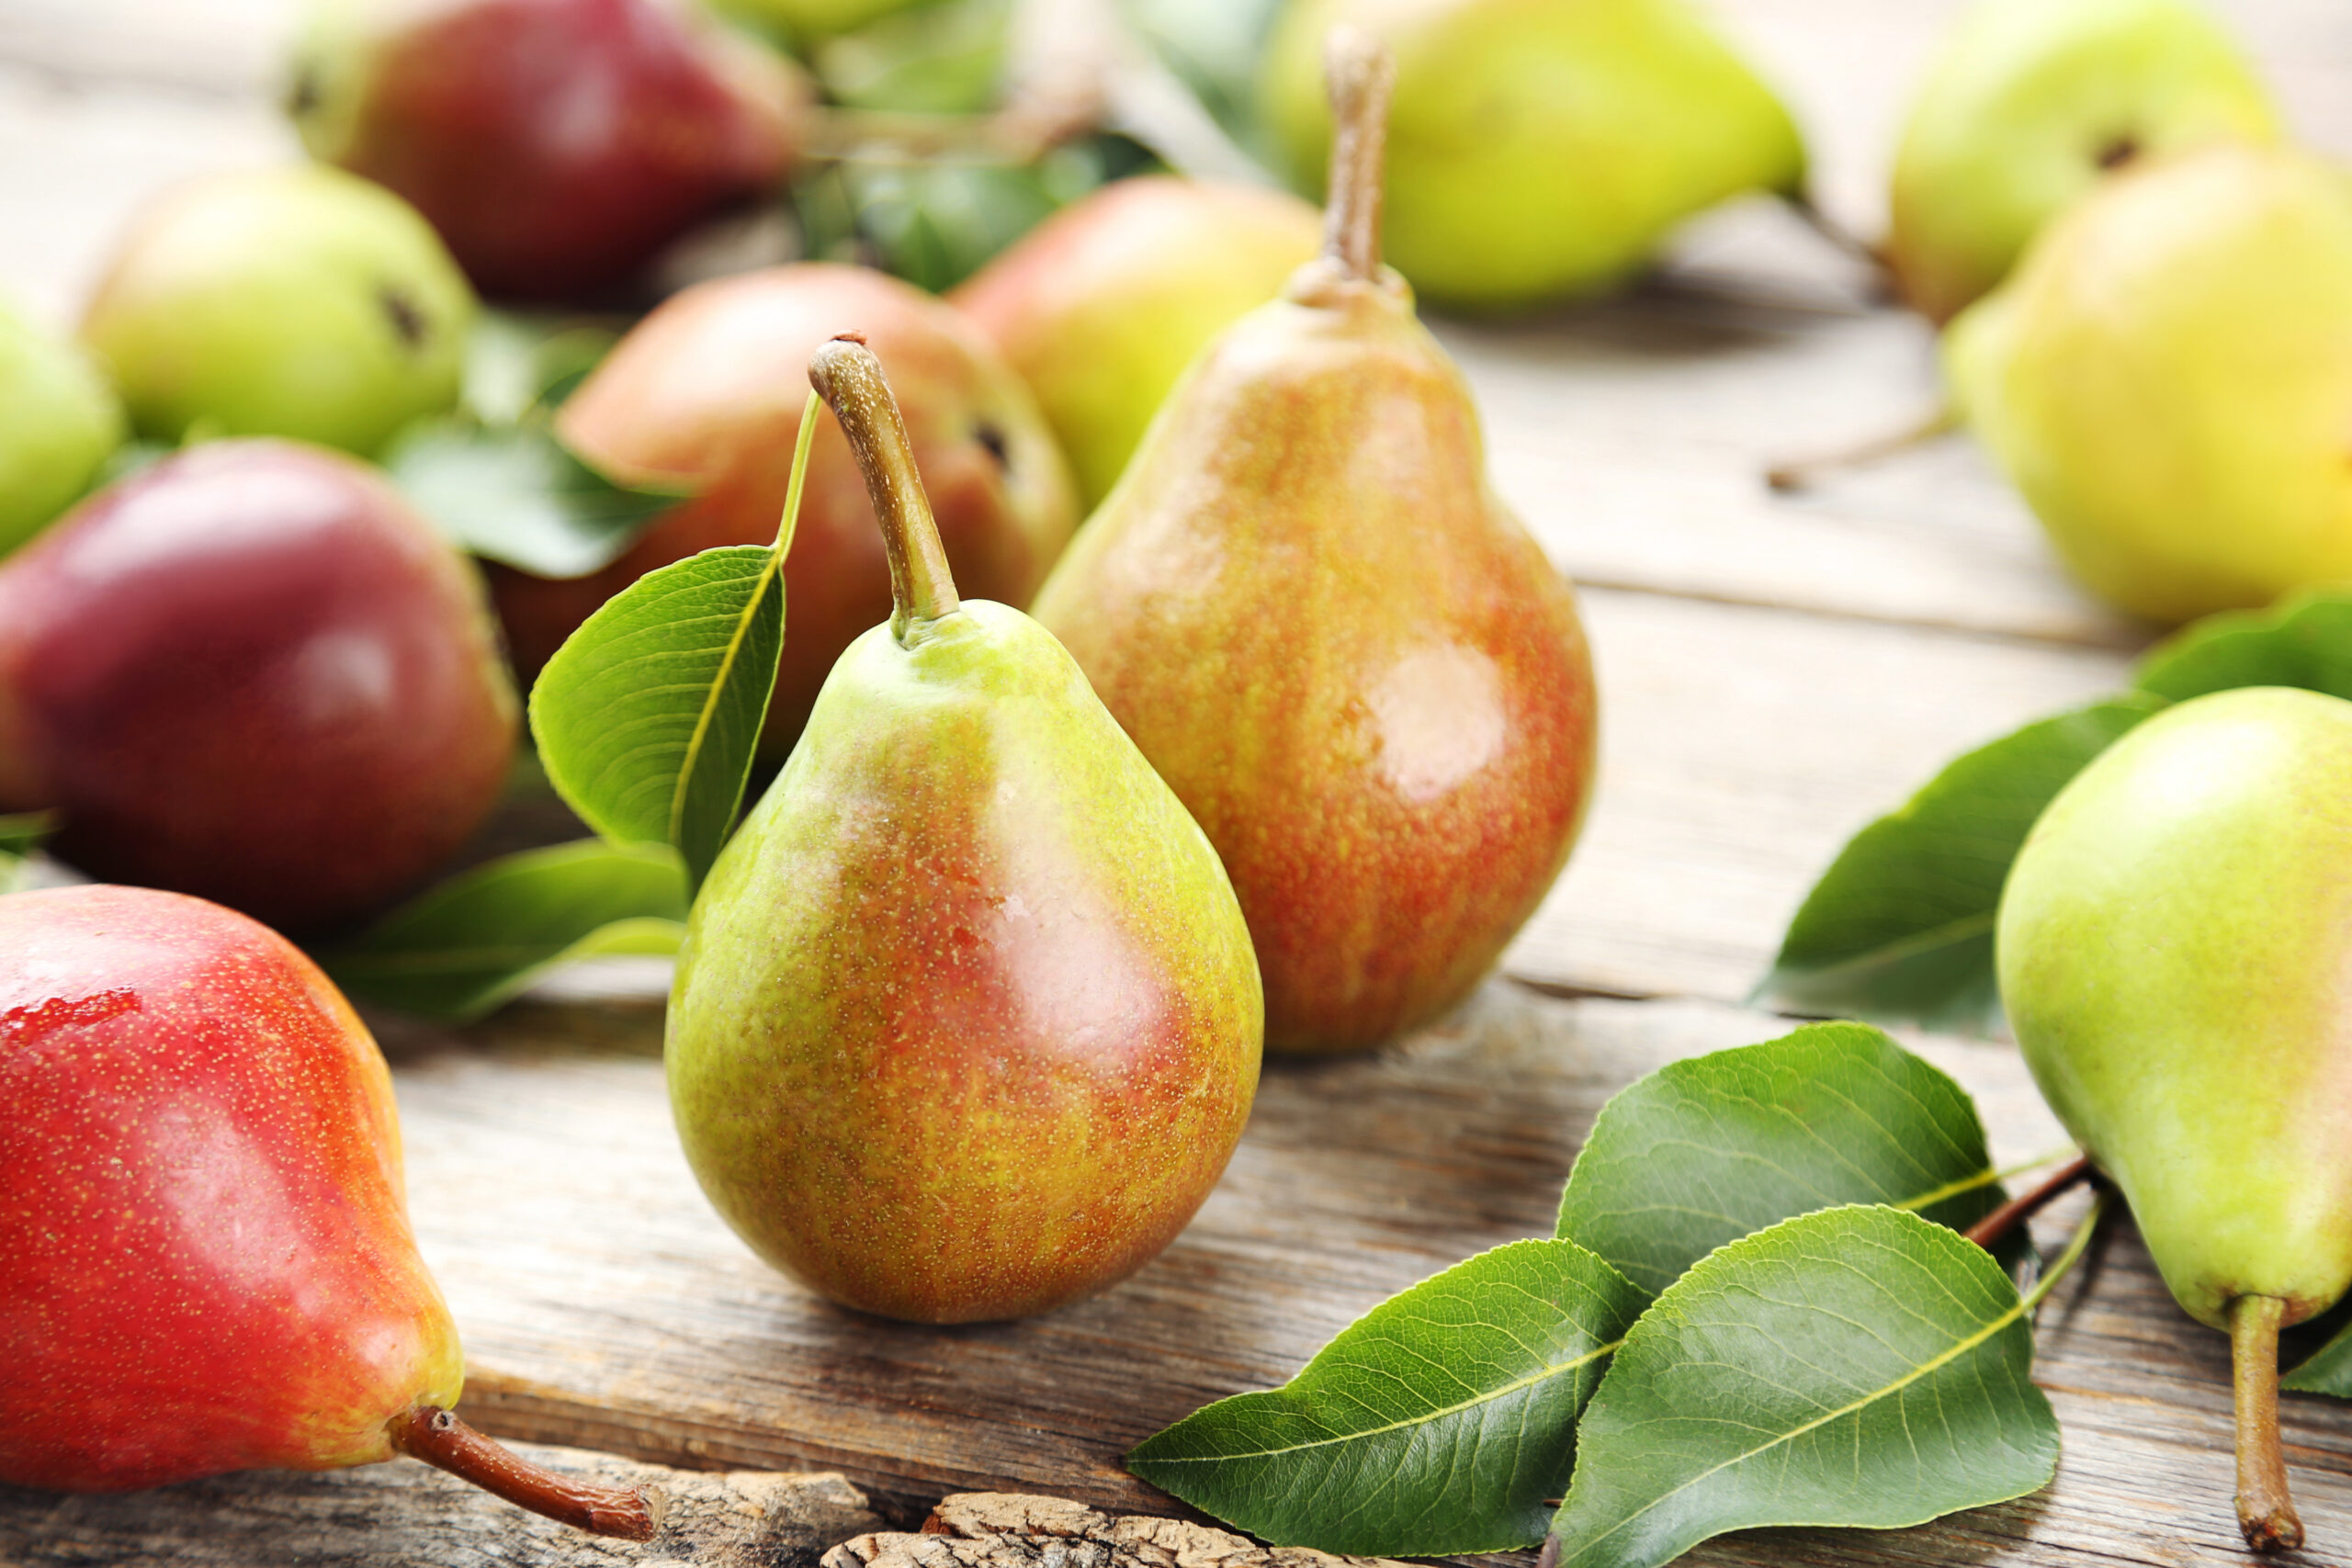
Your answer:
[1126,1022,2088,1568]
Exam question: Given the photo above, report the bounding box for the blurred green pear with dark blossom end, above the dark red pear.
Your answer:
[83,164,475,456]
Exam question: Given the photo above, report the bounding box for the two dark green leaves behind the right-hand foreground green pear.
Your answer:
[1757,590,2352,1032]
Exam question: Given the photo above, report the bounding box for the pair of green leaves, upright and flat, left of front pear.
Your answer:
[318,376,820,1022]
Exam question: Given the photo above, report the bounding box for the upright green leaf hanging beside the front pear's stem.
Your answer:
[532,392,823,896]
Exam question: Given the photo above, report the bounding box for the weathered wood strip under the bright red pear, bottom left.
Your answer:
[0,1443,882,1568]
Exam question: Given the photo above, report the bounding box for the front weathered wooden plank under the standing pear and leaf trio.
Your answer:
[347,983,2352,1563]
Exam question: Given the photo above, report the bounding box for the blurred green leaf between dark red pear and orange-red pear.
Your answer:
[383,416,677,579]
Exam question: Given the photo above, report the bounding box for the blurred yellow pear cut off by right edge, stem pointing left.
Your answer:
[1945,146,2352,621]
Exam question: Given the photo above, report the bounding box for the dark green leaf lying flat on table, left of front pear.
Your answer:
[318,840,687,1022]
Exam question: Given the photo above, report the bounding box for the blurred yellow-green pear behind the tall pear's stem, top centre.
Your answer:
[1259,0,1804,310]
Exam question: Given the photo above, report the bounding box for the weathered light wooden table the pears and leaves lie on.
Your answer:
[0,0,2352,1563]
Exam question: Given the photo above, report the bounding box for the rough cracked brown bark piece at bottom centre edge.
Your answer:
[820,1493,1397,1568]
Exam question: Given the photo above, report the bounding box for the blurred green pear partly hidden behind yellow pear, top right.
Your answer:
[1886,0,2281,322]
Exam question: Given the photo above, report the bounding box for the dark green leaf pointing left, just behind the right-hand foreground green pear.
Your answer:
[1757,694,2164,1032]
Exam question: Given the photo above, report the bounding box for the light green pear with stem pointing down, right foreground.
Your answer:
[1995,686,2352,1550]
